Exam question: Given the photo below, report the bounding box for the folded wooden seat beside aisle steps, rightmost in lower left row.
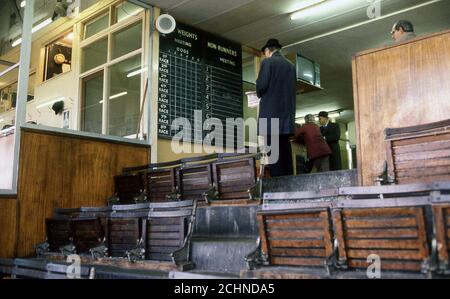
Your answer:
[142,200,197,270]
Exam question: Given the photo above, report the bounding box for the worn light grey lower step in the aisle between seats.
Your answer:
[191,237,257,275]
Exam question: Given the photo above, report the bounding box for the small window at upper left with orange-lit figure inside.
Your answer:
[44,32,73,81]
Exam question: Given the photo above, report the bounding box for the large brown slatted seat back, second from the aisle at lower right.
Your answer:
[333,198,431,272]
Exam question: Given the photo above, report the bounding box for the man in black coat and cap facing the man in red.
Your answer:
[319,111,341,170]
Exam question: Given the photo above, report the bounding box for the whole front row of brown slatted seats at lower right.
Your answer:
[246,182,450,278]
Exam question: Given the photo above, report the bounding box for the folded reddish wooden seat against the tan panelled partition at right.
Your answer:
[385,119,450,184]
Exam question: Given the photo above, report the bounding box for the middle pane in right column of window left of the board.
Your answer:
[112,22,142,59]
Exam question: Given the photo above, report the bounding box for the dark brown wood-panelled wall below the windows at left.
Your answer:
[0,130,150,257]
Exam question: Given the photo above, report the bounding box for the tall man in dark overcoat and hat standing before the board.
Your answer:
[256,39,297,176]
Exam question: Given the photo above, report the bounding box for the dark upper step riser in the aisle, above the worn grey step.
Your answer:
[194,204,260,238]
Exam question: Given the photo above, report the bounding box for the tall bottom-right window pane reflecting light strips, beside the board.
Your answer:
[108,55,142,137]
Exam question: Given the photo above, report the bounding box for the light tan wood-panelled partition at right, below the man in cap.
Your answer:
[353,31,450,186]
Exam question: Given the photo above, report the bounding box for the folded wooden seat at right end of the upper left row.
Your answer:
[212,154,261,200]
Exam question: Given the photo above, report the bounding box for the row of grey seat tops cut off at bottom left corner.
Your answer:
[12,259,95,279]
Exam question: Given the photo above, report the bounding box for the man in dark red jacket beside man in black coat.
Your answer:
[295,114,331,172]
